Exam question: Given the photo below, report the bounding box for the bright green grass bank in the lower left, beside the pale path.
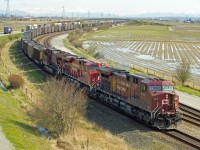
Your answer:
[0,90,51,150]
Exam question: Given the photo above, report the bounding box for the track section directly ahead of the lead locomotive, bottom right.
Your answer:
[162,130,200,149]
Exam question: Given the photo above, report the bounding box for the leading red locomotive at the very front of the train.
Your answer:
[95,67,180,129]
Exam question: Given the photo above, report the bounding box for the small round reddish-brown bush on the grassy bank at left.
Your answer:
[8,74,24,88]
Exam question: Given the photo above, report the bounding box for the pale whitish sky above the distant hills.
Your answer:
[0,0,200,16]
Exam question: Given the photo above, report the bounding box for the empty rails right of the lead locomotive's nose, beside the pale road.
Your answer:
[180,104,200,127]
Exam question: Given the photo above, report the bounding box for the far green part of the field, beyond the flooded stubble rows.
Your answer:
[84,21,200,42]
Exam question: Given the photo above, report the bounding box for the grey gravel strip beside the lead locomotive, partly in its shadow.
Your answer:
[86,99,193,150]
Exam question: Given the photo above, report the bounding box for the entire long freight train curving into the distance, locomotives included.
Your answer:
[21,22,181,130]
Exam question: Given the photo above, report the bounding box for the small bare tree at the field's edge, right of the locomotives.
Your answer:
[176,59,191,84]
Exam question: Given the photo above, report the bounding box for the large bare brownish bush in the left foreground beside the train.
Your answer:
[30,78,87,137]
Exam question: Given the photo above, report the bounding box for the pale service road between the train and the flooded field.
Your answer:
[51,34,200,110]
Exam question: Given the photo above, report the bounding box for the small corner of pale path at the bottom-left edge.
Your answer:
[0,126,14,150]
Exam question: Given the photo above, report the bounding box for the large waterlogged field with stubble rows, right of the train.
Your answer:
[84,23,200,86]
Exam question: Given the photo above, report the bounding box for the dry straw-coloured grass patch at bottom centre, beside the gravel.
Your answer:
[59,120,132,150]
